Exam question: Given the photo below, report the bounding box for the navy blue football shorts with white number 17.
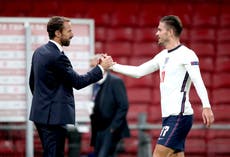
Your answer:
[157,115,193,152]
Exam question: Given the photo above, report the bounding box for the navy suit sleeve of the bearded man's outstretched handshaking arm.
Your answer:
[54,55,103,89]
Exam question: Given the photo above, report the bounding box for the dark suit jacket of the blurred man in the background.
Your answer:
[91,73,130,145]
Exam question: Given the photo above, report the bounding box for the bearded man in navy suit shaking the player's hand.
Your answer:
[29,16,112,157]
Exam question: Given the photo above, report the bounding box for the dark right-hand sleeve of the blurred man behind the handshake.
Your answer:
[111,79,128,130]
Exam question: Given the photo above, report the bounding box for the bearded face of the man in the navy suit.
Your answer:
[60,22,73,46]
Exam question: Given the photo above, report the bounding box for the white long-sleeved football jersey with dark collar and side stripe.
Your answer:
[112,45,210,117]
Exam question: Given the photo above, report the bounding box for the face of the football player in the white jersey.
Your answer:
[156,22,170,46]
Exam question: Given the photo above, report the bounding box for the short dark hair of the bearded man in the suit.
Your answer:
[47,16,70,39]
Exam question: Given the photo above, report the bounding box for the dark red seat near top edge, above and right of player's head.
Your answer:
[192,3,219,27]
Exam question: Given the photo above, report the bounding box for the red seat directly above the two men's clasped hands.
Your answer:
[105,42,132,57]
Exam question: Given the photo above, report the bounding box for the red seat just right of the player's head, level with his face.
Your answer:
[190,28,216,43]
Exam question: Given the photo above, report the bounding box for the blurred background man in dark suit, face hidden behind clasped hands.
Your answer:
[90,54,130,157]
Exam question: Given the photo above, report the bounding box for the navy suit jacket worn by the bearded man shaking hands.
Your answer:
[29,42,102,125]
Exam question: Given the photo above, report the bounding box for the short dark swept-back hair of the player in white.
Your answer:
[160,15,183,37]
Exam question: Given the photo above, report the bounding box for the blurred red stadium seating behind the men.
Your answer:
[0,0,230,157]
